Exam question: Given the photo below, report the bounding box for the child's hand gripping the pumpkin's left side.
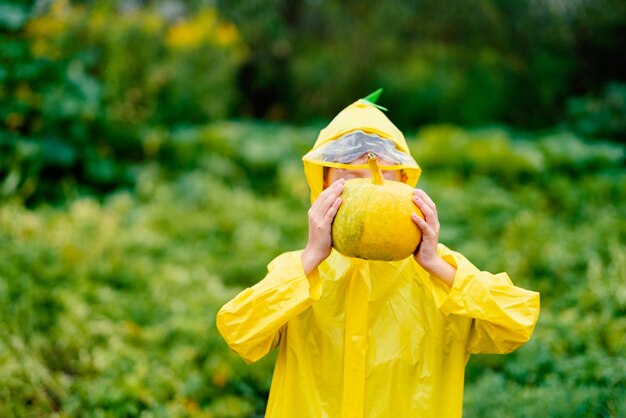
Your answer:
[302,178,345,275]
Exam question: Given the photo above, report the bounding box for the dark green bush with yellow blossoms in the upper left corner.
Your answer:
[0,1,243,203]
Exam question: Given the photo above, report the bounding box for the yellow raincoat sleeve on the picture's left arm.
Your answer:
[216,251,322,363]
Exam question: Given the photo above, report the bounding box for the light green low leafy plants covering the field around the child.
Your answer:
[0,122,626,417]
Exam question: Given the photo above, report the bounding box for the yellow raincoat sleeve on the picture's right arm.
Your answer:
[432,244,539,354]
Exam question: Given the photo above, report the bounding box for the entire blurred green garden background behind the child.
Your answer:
[0,0,626,418]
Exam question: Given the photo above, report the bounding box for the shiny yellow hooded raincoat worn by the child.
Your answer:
[217,95,539,418]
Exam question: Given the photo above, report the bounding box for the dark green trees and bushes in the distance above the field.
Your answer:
[0,0,626,205]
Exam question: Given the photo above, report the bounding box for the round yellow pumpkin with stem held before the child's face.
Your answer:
[332,153,424,261]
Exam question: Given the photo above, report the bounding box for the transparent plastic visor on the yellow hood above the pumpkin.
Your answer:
[304,131,417,170]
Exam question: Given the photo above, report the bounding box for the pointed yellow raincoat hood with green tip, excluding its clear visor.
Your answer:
[302,89,422,203]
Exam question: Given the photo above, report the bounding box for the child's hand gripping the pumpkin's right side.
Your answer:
[413,189,456,286]
